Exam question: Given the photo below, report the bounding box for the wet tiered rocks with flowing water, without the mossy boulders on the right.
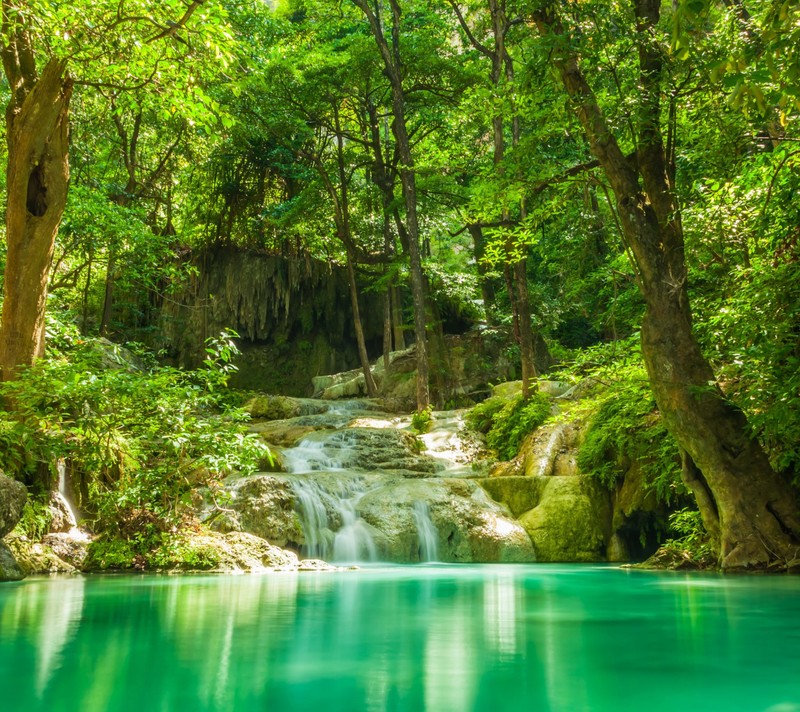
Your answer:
[208,400,535,563]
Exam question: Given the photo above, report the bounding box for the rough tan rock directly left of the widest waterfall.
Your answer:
[211,475,303,546]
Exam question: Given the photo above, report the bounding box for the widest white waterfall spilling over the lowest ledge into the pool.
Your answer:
[291,476,378,563]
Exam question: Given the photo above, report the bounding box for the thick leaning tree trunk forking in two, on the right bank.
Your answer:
[535,0,800,569]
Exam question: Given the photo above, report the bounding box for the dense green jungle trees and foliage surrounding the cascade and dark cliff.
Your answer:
[0,0,800,569]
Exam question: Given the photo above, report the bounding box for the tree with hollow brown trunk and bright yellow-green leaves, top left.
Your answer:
[0,0,230,380]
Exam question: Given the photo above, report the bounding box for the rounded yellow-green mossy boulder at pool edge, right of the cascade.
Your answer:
[519,477,611,561]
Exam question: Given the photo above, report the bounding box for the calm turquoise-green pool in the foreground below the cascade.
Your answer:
[0,565,800,712]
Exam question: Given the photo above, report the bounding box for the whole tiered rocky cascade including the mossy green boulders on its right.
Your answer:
[220,377,666,562]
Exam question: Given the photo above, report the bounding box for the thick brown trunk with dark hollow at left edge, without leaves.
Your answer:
[0,58,72,380]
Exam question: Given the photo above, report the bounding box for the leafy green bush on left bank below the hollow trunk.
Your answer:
[0,326,268,538]
